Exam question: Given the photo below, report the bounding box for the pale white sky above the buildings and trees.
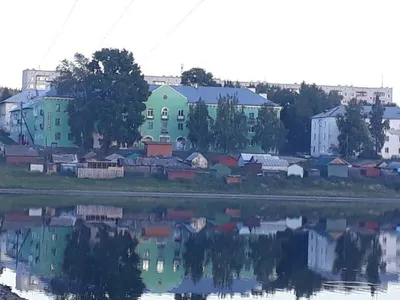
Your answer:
[0,0,400,103]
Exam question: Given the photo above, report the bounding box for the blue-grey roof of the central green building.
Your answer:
[150,85,278,106]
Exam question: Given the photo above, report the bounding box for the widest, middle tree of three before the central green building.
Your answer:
[213,95,248,153]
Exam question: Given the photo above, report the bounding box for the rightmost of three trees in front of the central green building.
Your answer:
[253,105,287,152]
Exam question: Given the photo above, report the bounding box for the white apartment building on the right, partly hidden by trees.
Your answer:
[310,105,400,159]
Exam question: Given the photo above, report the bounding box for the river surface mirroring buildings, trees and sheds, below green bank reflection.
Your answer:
[0,205,400,300]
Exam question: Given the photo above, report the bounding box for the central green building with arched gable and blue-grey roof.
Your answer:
[140,85,281,153]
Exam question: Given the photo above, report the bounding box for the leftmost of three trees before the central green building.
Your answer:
[186,99,212,151]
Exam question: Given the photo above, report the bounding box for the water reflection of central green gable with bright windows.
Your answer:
[136,227,184,293]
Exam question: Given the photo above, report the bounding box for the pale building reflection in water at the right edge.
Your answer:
[379,231,400,274]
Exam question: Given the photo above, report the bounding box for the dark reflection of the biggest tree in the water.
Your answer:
[51,227,144,300]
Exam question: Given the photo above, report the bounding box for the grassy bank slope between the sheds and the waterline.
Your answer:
[0,165,400,198]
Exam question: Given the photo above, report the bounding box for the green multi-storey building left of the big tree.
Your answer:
[10,90,75,147]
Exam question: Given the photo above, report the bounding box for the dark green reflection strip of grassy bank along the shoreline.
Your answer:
[0,195,400,222]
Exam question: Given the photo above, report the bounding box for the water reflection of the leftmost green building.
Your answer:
[20,226,73,276]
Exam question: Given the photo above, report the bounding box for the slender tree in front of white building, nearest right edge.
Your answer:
[368,96,390,155]
